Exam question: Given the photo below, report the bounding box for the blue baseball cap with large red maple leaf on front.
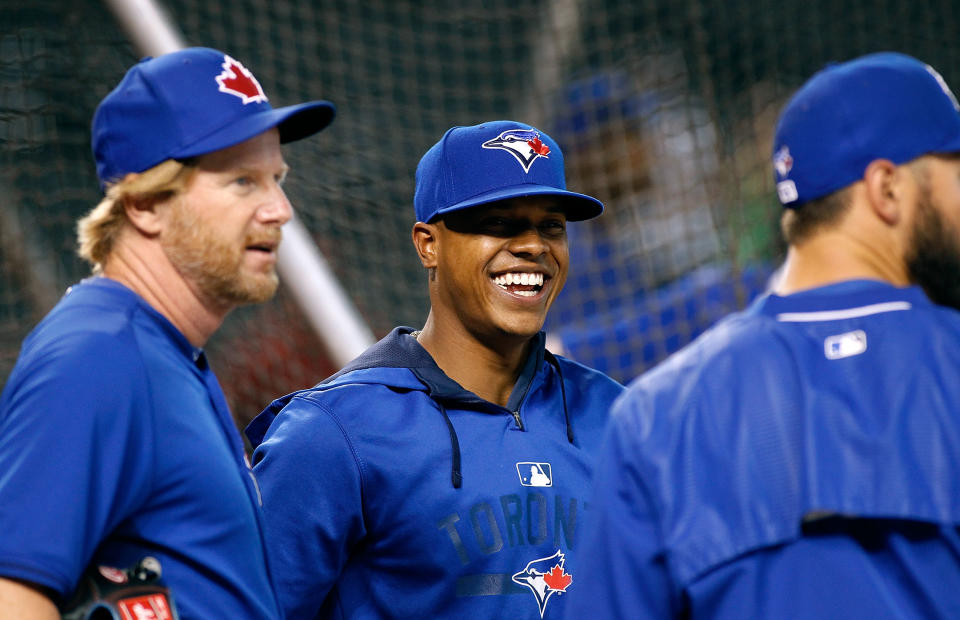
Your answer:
[92,47,335,186]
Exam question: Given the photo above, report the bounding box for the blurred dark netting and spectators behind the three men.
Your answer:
[0,0,960,432]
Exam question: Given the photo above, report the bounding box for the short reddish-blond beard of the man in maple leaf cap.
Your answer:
[163,201,280,310]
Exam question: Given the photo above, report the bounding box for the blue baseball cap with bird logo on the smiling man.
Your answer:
[413,121,603,222]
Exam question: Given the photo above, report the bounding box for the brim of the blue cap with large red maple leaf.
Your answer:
[171,101,336,159]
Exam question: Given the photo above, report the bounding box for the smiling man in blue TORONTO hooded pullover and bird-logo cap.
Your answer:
[247,121,622,619]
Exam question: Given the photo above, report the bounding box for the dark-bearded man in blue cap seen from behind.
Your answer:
[567,52,960,619]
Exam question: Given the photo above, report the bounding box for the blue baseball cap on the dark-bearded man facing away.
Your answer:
[773,52,960,208]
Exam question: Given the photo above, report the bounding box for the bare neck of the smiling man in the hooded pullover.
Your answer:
[417,310,531,407]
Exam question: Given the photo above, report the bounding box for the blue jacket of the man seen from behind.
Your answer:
[567,281,960,620]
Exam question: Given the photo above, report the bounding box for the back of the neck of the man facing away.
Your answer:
[775,230,910,295]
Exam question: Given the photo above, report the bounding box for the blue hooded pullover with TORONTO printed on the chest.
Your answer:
[247,328,623,619]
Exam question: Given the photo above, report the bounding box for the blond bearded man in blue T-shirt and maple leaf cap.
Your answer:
[0,48,334,620]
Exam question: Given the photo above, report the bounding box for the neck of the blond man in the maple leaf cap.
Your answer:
[103,231,230,347]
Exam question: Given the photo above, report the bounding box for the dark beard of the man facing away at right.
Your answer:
[906,187,960,310]
